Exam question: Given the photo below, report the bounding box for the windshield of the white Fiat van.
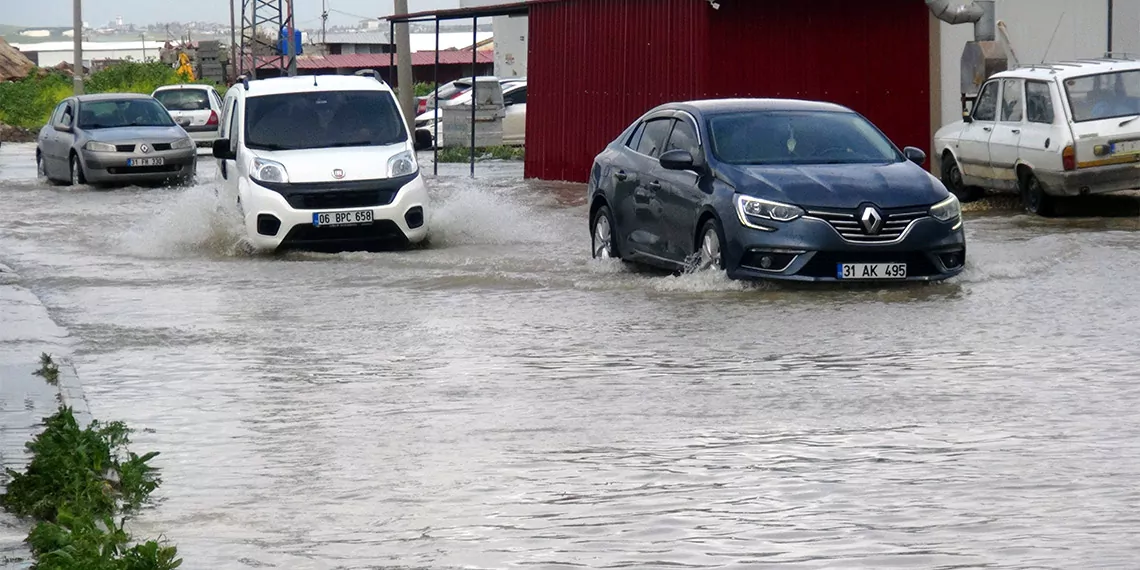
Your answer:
[245,91,407,150]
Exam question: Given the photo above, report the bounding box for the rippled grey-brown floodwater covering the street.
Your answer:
[0,140,1140,569]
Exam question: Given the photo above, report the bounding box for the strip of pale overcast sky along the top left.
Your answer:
[0,0,459,27]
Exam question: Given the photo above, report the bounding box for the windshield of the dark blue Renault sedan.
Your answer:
[709,111,905,164]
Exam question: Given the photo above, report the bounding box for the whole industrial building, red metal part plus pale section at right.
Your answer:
[396,0,1140,181]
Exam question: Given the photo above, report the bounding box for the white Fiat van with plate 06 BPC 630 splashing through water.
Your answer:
[213,75,429,251]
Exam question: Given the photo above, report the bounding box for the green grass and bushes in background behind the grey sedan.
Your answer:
[0,62,225,130]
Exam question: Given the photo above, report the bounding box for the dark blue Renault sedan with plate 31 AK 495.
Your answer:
[588,99,966,282]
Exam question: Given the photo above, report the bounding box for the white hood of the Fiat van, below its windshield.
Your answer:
[250,143,415,182]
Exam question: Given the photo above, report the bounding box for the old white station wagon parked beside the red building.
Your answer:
[935,58,1140,215]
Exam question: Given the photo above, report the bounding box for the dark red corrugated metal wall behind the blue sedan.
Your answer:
[526,0,930,181]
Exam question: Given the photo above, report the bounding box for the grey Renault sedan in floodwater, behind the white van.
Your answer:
[35,93,197,185]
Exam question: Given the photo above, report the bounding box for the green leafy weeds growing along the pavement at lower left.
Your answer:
[0,355,182,570]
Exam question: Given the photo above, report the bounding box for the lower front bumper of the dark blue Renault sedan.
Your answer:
[725,218,966,283]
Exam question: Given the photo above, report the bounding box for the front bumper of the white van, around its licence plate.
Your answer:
[242,172,430,251]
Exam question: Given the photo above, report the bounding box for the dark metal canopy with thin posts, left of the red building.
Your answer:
[382,0,526,178]
